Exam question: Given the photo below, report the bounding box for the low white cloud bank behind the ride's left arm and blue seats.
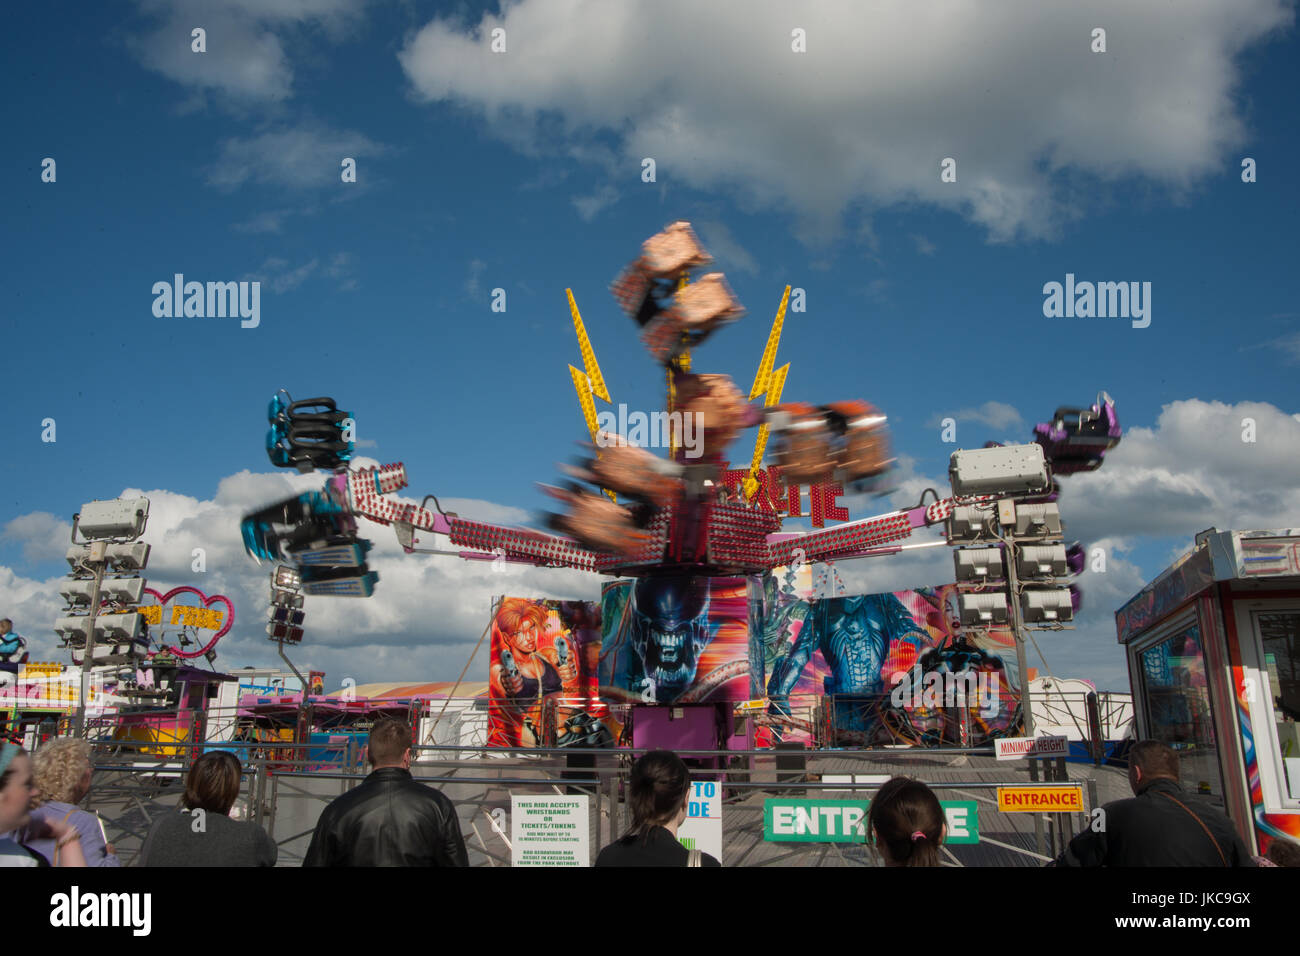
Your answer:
[0,473,603,687]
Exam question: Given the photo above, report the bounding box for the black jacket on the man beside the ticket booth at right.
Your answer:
[1056,778,1255,866]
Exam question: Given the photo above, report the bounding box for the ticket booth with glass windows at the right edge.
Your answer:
[1115,528,1300,853]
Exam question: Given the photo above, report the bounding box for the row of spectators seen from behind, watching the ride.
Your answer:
[0,718,1300,866]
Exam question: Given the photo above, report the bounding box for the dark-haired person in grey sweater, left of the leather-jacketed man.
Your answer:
[140,750,278,866]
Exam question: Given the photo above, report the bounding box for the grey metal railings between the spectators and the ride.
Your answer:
[68,741,1125,866]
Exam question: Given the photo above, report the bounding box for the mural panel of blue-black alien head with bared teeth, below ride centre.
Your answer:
[601,576,750,704]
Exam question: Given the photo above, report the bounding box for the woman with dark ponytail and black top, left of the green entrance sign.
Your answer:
[595,750,722,866]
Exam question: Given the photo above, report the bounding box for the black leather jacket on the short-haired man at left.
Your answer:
[303,767,469,866]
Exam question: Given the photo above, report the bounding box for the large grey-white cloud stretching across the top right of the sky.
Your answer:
[398,0,1294,239]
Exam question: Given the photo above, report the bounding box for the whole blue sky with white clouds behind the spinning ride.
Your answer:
[0,0,1300,688]
